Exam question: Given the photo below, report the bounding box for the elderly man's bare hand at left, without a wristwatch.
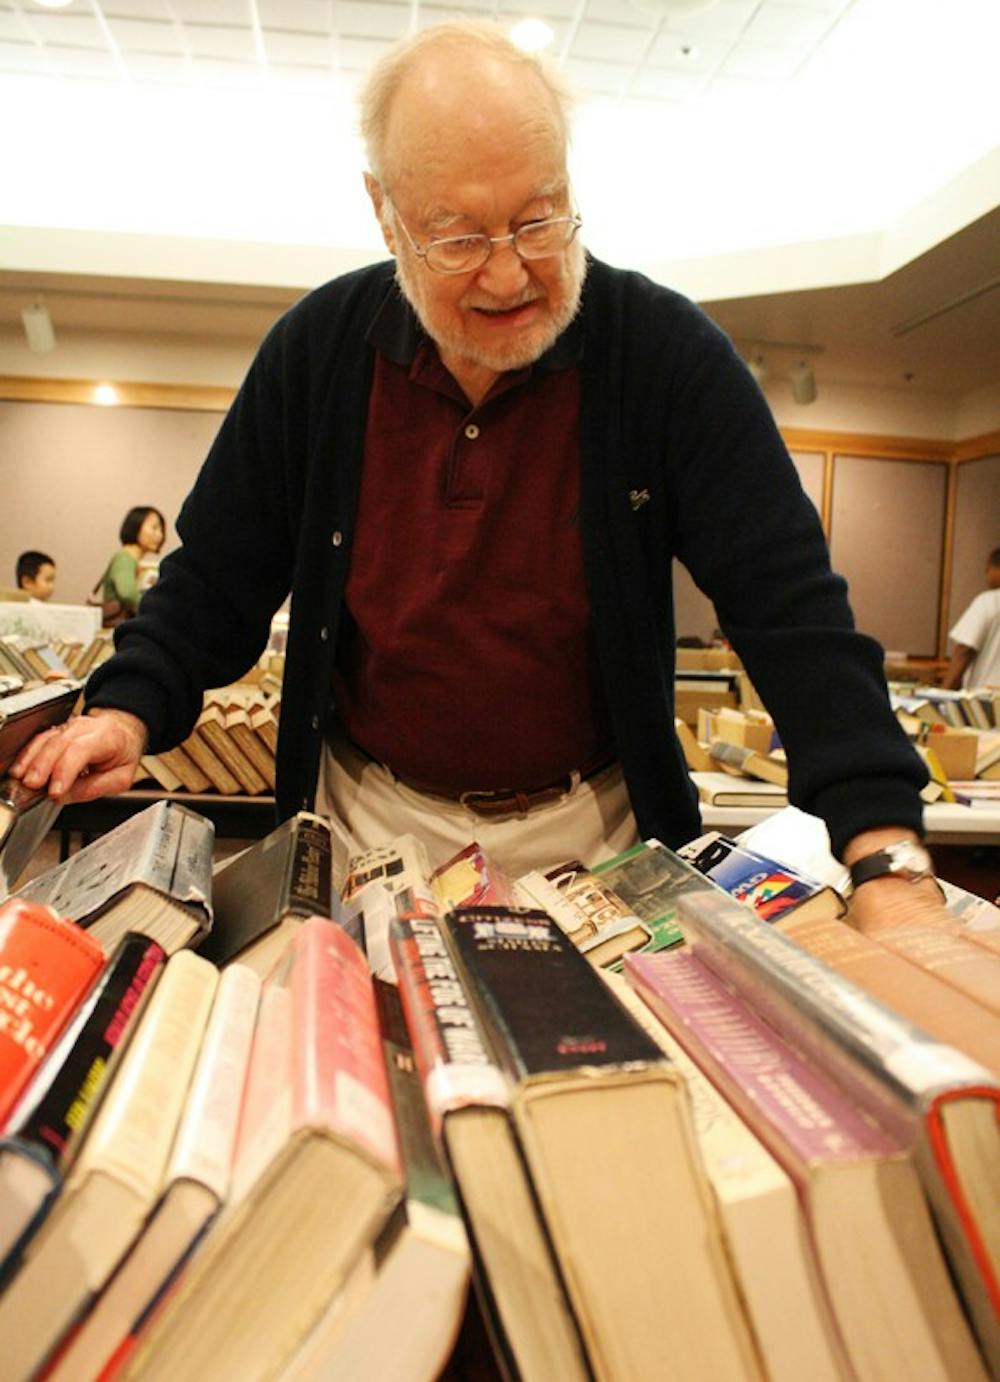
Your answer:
[10,710,146,806]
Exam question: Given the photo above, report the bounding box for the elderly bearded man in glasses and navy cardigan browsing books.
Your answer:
[17,25,939,925]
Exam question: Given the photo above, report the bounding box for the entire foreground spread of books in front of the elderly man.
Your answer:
[0,779,1000,1382]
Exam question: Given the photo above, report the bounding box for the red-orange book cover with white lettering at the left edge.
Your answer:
[0,898,105,1129]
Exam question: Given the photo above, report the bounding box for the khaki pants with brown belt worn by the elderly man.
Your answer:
[316,741,638,887]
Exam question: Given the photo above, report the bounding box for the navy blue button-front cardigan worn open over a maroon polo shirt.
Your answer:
[87,260,925,851]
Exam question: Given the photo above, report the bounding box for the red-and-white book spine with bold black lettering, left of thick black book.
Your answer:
[390,911,510,1133]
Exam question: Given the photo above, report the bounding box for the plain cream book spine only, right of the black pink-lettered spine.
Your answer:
[70,951,218,1202]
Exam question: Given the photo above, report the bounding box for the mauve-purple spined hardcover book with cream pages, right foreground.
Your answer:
[626,951,985,1382]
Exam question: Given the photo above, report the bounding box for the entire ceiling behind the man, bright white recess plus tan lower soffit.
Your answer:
[0,0,1000,392]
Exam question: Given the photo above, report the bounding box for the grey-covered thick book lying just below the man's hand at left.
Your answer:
[17,802,214,954]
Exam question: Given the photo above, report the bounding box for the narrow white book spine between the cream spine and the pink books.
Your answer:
[167,965,261,1204]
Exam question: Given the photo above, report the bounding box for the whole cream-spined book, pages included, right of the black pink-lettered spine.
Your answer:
[0,951,218,1382]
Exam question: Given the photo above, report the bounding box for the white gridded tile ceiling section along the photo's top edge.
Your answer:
[0,0,861,101]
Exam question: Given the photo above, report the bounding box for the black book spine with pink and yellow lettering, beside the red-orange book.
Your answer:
[15,934,166,1175]
